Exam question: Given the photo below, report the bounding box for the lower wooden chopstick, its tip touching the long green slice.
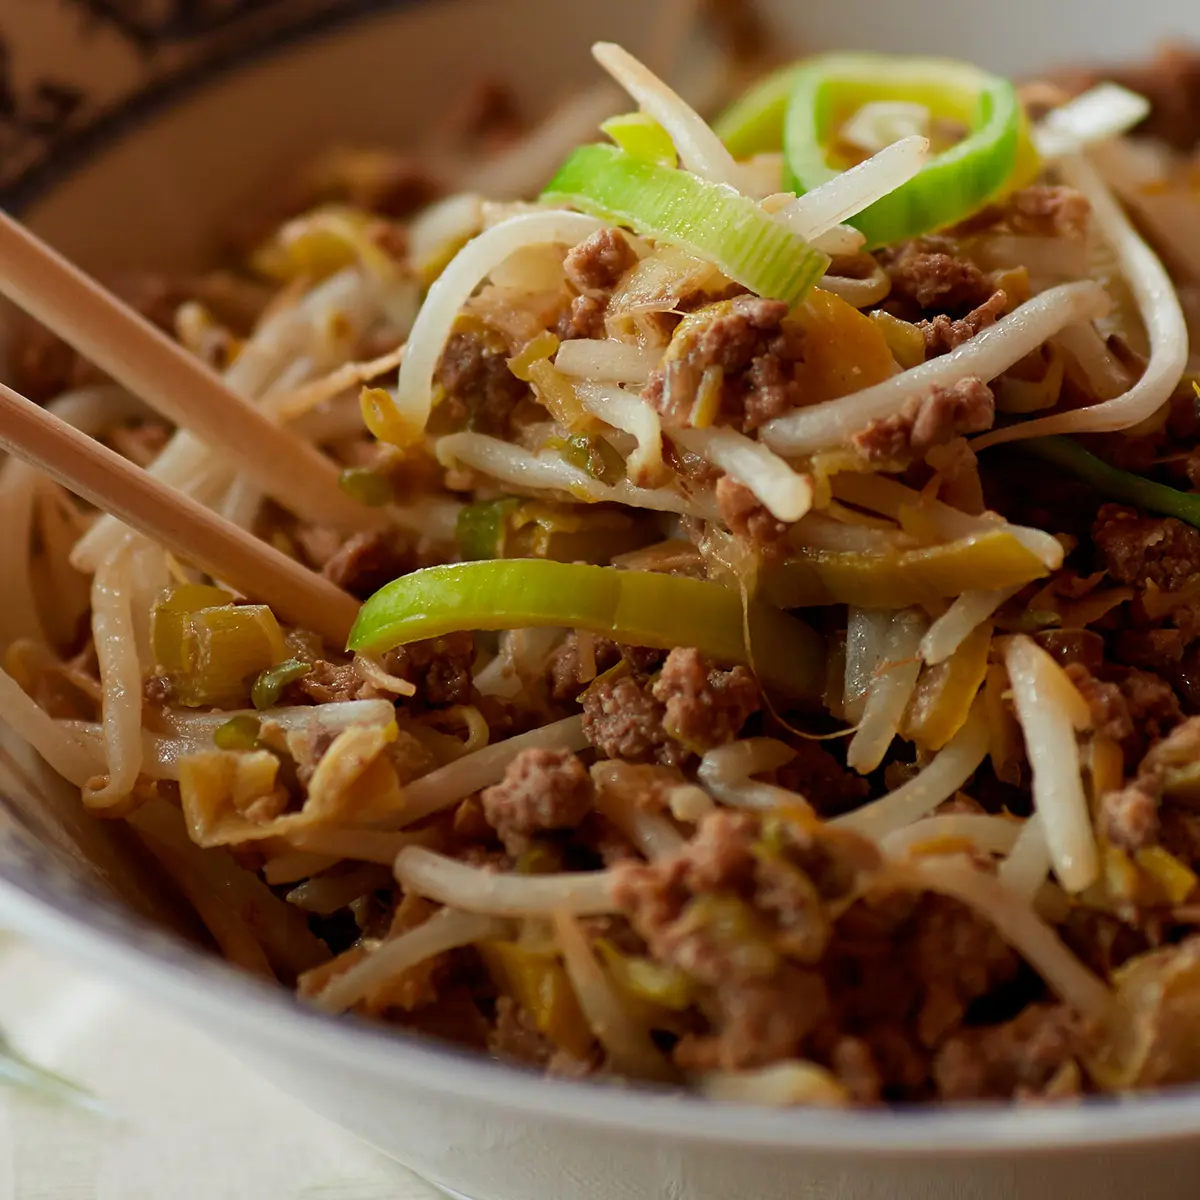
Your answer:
[0,384,359,648]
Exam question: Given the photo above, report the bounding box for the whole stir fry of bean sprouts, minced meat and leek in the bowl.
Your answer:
[7,28,1200,1105]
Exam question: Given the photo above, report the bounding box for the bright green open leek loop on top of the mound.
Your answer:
[784,54,1021,246]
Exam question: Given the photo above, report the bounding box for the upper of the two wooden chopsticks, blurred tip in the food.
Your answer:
[0,211,376,530]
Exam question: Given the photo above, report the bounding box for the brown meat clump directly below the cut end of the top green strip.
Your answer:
[642,295,803,433]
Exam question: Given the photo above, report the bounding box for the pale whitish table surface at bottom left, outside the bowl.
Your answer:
[0,934,442,1200]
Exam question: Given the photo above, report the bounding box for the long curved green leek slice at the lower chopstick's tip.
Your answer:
[349,559,826,698]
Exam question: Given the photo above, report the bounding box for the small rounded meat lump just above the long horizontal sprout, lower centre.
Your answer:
[479,749,593,854]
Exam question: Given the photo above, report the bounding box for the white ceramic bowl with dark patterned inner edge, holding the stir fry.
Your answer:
[0,0,1200,1200]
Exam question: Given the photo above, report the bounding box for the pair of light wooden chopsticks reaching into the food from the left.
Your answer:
[0,212,364,646]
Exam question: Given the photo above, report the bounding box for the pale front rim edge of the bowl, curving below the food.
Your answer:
[0,872,1200,1158]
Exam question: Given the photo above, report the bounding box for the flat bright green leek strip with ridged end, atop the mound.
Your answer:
[542,144,829,305]
